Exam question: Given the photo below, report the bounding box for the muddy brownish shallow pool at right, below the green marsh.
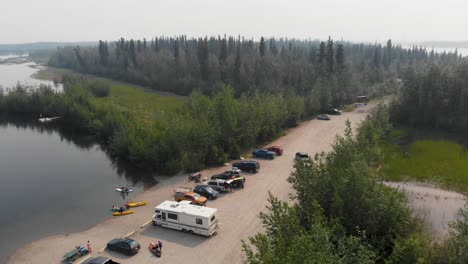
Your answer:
[385,182,467,240]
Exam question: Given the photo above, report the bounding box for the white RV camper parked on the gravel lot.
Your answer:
[153,201,219,236]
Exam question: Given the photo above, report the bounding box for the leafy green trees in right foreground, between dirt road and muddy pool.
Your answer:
[243,107,468,264]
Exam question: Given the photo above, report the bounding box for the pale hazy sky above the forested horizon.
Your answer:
[0,0,468,43]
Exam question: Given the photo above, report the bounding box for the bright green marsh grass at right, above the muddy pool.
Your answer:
[383,130,468,194]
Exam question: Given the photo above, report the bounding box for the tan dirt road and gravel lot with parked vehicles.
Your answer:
[8,105,371,264]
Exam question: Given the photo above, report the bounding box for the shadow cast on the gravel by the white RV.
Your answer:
[140,225,210,248]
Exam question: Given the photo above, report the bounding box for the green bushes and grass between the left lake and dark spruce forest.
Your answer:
[0,76,303,173]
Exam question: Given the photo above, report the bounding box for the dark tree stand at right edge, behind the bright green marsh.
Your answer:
[392,54,468,133]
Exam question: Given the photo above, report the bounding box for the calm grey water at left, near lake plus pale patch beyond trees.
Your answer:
[0,56,156,263]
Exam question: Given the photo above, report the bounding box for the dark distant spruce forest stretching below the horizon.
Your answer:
[49,36,447,109]
